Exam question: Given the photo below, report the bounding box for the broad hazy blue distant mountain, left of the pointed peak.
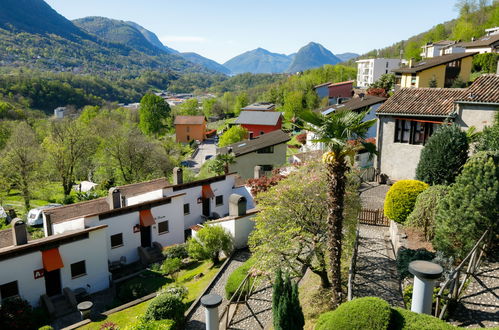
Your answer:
[223,48,292,74]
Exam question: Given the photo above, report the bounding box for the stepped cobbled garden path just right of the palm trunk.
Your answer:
[353,224,404,307]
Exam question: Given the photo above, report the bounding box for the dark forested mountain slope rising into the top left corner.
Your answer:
[0,0,207,74]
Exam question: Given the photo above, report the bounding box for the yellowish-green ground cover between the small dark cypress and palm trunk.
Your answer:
[298,271,331,330]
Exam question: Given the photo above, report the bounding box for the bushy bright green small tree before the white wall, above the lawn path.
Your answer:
[187,225,234,264]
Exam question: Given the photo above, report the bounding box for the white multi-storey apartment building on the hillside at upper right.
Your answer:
[357,58,400,88]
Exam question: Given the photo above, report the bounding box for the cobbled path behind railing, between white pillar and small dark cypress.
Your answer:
[229,279,272,330]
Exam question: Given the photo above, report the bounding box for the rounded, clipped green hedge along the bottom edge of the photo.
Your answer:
[315,297,455,330]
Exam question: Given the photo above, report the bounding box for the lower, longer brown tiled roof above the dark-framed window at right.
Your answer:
[376,88,468,117]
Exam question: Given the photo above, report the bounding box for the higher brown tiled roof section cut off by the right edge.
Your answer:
[457,74,499,103]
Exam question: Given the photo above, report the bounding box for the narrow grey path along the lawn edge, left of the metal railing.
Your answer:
[185,251,250,330]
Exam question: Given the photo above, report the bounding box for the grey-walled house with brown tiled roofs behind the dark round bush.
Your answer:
[376,74,499,180]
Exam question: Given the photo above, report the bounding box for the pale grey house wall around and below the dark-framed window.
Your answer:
[378,116,423,180]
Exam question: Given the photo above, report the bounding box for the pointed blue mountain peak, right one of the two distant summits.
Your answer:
[286,42,341,72]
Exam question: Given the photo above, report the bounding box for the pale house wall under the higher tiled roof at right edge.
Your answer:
[456,103,499,131]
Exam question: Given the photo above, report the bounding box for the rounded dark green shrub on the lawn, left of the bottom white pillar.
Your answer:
[144,293,185,326]
